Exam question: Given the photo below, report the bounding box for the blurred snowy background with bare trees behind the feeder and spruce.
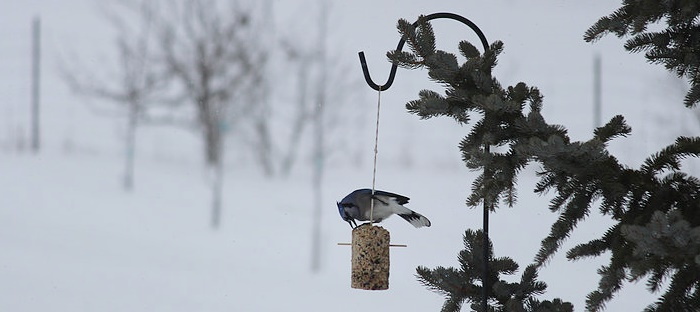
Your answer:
[0,0,700,311]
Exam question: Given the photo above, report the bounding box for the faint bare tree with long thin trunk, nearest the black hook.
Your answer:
[270,0,363,272]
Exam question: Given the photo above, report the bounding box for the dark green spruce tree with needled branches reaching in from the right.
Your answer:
[387,1,700,311]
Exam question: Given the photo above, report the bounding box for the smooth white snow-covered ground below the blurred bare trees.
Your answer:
[0,150,649,311]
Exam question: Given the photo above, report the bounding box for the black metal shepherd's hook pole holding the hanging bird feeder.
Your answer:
[358,13,491,312]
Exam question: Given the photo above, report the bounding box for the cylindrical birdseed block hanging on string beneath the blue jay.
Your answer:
[350,224,390,290]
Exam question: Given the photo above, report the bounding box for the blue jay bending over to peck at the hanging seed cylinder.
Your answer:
[336,189,430,228]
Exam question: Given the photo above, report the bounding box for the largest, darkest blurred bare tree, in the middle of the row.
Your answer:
[158,0,265,228]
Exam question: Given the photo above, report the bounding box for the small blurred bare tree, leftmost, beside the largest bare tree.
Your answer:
[60,0,165,190]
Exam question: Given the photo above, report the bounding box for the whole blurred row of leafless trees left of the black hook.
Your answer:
[61,0,359,233]
